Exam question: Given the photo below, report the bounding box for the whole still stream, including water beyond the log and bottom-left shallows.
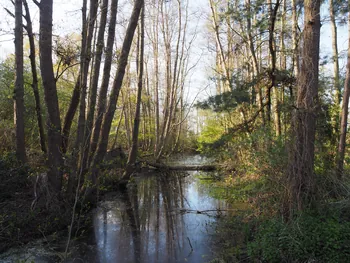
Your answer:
[0,155,230,263]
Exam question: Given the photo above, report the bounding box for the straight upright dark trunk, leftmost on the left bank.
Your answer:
[14,0,26,163]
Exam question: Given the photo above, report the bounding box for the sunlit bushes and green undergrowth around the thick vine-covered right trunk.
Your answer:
[202,127,350,262]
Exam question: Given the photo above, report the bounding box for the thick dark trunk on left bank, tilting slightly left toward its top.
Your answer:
[39,0,63,194]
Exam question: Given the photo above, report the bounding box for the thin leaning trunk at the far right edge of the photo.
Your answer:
[337,5,350,178]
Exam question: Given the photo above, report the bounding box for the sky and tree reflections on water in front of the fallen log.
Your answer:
[86,168,230,262]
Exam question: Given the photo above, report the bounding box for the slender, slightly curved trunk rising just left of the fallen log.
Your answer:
[122,3,145,181]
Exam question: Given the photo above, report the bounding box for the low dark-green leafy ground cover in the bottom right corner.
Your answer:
[248,213,350,262]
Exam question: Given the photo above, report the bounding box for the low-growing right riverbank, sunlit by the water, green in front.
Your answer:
[205,158,350,263]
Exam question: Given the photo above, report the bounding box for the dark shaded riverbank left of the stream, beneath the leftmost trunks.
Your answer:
[0,156,71,253]
